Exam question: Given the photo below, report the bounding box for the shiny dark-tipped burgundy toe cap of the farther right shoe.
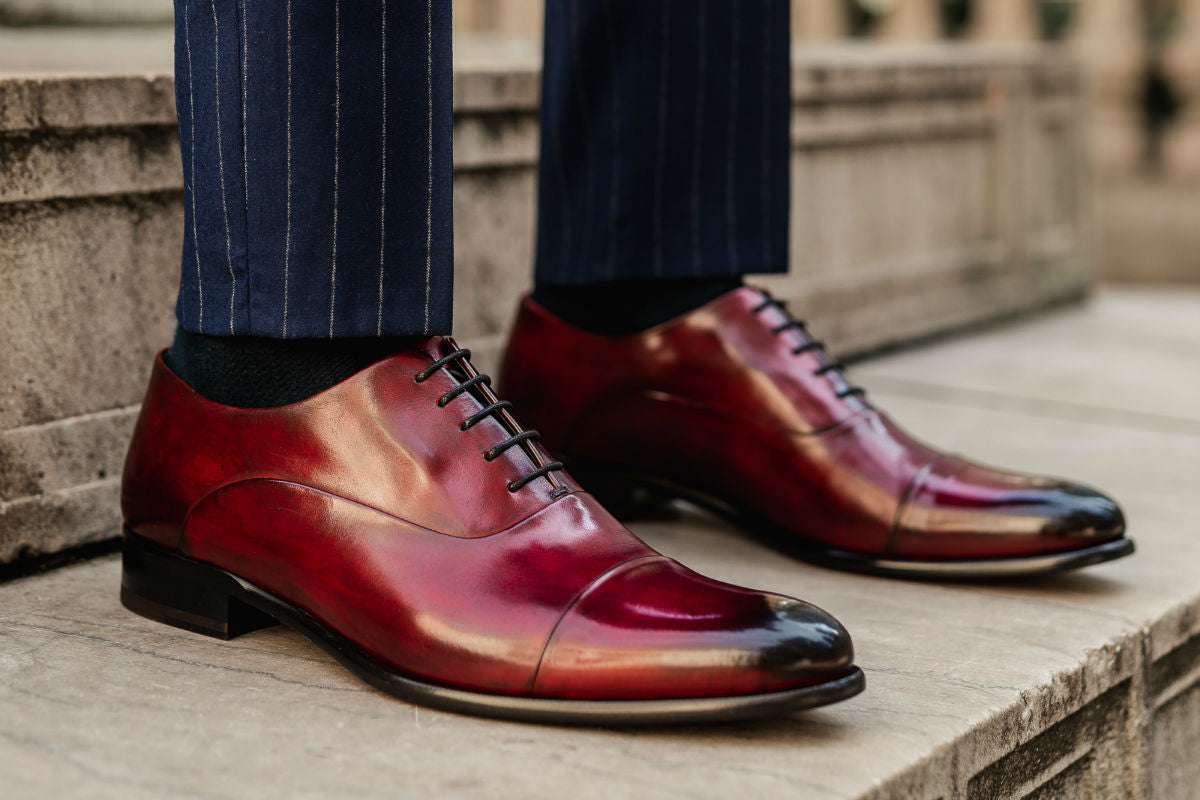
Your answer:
[892,457,1126,559]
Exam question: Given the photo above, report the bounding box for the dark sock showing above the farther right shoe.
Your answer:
[533,277,742,336]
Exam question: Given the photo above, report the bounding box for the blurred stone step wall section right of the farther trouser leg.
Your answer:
[770,47,1091,351]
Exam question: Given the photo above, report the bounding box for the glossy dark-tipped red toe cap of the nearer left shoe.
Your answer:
[533,557,854,699]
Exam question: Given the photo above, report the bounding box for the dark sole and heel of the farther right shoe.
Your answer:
[569,463,1136,581]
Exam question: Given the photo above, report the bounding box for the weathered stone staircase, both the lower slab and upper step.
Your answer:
[0,29,1200,800]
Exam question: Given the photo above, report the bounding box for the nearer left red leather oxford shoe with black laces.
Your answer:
[121,338,863,723]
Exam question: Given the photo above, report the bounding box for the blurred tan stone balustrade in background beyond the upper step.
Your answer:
[458,0,1200,282]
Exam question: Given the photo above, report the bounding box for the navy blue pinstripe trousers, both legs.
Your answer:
[175,0,790,338]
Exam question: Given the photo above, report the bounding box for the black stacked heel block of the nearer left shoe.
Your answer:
[121,533,277,639]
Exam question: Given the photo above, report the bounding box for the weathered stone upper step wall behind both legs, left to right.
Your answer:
[0,45,1090,564]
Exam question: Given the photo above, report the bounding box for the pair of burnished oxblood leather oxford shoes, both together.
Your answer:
[121,288,1133,724]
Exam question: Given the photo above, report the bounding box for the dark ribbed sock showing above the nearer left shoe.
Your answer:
[159,329,424,408]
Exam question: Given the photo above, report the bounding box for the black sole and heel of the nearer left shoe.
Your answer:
[121,531,866,726]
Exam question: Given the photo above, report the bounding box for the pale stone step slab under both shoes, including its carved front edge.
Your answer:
[0,290,1200,800]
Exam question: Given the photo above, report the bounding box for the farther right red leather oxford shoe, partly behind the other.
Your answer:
[502,288,1133,577]
